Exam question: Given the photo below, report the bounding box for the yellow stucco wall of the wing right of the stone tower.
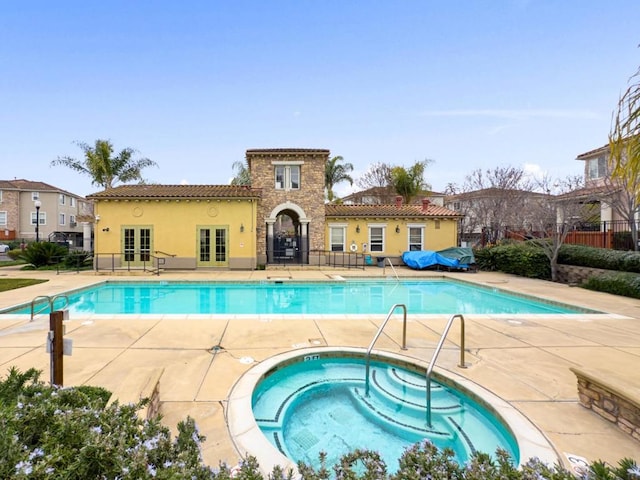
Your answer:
[325,217,458,256]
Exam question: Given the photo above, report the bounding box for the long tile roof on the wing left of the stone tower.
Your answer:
[87,185,260,200]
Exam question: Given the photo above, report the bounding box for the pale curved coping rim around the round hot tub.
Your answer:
[225,347,561,475]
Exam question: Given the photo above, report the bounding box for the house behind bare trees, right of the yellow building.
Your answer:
[444,188,551,246]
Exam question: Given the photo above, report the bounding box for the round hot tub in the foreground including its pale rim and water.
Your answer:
[228,348,557,471]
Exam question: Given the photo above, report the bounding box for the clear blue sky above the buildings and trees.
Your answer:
[0,0,640,195]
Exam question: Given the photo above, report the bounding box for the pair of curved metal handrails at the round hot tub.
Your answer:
[364,303,467,427]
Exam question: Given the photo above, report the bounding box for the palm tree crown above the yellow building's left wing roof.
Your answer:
[51,140,157,189]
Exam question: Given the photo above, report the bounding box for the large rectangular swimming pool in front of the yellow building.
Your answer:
[0,279,593,316]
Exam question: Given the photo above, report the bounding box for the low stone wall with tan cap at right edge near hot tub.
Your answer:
[571,368,640,441]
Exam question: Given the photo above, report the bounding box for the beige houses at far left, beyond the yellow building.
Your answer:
[0,179,93,250]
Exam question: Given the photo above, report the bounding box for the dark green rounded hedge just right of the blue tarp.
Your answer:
[474,242,551,280]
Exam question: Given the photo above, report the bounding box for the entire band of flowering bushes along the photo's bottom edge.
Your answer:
[0,368,640,480]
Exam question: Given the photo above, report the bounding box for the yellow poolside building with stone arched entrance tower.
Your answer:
[88,149,459,269]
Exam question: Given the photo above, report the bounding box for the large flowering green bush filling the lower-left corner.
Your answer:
[0,369,218,479]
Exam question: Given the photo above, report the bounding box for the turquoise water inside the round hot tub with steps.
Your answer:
[252,355,519,472]
